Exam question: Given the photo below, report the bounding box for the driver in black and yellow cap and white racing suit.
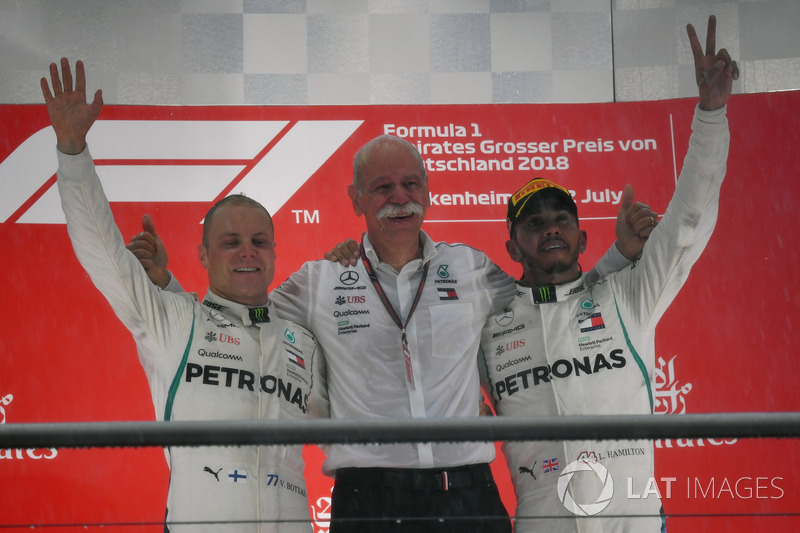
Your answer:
[481,17,738,533]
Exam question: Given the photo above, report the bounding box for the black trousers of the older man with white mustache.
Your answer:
[330,464,511,533]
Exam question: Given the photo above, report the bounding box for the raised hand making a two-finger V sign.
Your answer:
[686,15,739,111]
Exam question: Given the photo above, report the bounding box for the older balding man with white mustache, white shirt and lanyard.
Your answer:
[271,135,641,533]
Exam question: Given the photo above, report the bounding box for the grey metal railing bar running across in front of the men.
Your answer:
[0,412,800,448]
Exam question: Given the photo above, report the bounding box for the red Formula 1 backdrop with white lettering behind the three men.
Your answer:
[0,92,800,532]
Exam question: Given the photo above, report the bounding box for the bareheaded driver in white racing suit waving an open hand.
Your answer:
[42,59,321,533]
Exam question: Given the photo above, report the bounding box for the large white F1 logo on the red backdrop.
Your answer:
[0,120,363,224]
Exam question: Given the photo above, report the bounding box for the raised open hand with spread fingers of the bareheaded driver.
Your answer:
[40,57,103,155]
